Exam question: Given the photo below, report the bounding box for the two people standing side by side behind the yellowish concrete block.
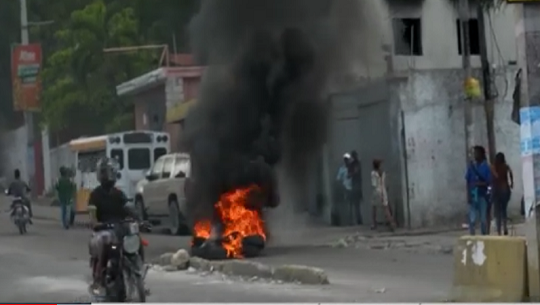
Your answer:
[465,146,514,235]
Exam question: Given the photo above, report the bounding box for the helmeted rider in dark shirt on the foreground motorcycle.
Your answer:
[88,157,144,293]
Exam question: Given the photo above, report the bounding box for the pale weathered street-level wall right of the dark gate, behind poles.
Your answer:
[395,69,522,227]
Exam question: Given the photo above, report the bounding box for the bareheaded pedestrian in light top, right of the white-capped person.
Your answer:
[371,159,397,231]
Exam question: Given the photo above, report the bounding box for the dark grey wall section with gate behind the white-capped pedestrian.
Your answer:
[328,81,404,225]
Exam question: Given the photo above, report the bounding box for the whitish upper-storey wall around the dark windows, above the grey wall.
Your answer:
[342,0,517,74]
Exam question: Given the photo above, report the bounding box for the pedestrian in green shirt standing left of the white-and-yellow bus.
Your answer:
[55,166,76,229]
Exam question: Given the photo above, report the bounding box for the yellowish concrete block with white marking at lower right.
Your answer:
[450,236,528,302]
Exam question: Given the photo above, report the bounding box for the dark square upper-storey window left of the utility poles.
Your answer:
[392,18,423,56]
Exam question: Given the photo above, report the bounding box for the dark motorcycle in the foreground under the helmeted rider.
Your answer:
[90,220,148,303]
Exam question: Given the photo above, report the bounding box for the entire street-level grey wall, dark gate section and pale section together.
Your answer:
[325,68,523,227]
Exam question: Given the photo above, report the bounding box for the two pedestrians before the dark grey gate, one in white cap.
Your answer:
[336,150,397,230]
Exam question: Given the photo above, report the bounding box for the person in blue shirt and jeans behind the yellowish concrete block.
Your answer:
[465,146,492,235]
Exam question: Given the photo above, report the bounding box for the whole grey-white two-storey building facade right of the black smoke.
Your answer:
[324,0,523,227]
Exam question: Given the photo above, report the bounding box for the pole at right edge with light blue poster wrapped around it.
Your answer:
[513,3,540,302]
